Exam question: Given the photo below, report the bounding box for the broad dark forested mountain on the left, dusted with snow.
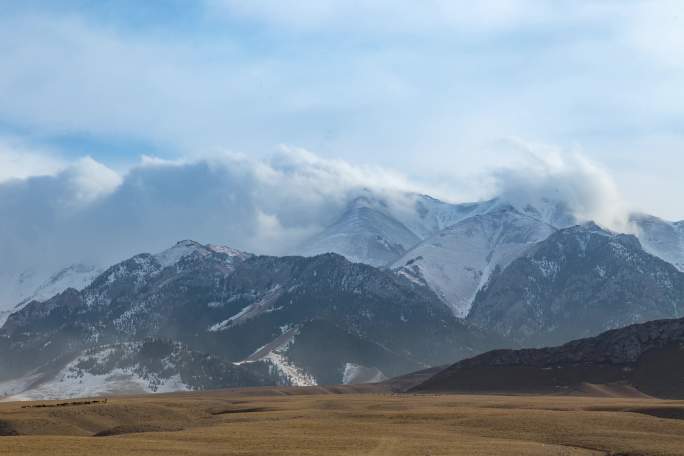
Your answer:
[0,241,496,398]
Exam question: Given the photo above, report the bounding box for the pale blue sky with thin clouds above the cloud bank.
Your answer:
[0,0,684,219]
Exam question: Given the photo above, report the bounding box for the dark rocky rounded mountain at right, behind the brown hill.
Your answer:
[468,223,684,345]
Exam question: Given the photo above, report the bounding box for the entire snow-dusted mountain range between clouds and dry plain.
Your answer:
[0,192,684,398]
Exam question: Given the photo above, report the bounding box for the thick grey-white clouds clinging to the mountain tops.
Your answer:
[0,142,656,286]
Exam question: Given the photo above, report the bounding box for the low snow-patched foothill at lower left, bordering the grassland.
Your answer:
[0,339,278,400]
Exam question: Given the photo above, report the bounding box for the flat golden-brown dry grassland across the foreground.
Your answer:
[0,388,684,456]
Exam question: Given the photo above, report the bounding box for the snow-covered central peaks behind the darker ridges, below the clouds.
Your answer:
[301,192,575,317]
